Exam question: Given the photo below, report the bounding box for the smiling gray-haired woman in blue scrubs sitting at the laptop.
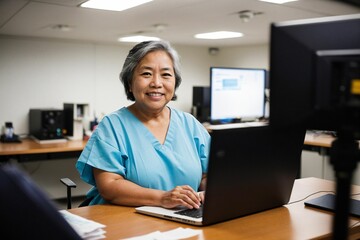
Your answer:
[76,41,210,209]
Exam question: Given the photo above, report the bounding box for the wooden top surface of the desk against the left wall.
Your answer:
[0,139,87,156]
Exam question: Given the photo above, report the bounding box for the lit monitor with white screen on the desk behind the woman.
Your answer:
[210,67,267,124]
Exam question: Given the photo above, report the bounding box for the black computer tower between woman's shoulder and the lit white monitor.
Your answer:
[191,86,210,122]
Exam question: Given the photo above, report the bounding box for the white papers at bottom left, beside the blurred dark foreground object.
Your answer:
[59,210,106,240]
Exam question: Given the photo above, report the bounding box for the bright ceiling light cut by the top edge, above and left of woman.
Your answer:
[80,0,152,11]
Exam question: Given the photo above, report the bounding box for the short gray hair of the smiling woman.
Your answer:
[120,41,182,101]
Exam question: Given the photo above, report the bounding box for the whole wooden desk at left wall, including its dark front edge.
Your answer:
[0,139,87,161]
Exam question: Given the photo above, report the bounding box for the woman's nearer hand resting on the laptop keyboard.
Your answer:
[161,185,201,209]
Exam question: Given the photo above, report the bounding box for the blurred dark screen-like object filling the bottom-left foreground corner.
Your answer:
[0,164,82,240]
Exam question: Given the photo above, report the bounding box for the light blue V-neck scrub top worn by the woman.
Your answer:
[76,107,210,205]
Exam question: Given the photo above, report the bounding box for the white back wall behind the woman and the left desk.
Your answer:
[0,36,268,198]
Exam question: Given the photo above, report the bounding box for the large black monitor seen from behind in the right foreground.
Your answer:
[269,14,360,131]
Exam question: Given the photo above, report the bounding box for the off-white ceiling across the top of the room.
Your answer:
[0,0,360,47]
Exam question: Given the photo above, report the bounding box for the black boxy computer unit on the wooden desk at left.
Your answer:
[29,109,64,140]
